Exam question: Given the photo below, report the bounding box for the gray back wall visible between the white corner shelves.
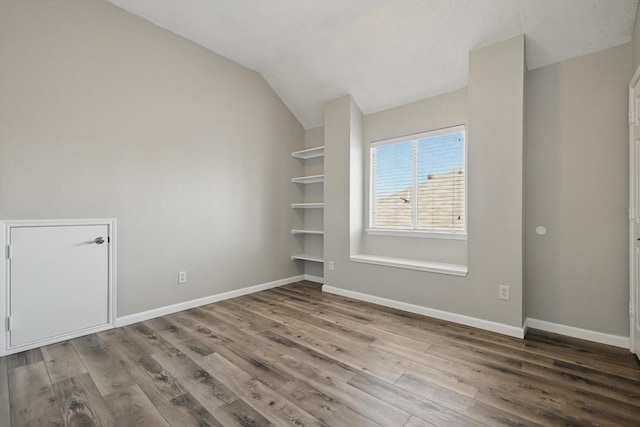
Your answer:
[298,127,324,277]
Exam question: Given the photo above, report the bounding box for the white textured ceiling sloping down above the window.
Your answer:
[107,0,637,129]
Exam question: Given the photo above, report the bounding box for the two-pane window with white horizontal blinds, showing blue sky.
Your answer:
[369,125,466,235]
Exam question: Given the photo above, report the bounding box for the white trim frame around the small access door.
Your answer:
[0,218,118,356]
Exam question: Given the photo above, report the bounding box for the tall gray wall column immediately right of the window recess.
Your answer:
[467,35,526,325]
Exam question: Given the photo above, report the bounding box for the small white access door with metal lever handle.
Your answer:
[3,223,114,354]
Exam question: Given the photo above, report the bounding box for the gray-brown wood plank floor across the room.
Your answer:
[0,282,640,427]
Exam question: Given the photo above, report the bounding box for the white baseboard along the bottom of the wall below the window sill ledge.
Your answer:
[322,285,524,338]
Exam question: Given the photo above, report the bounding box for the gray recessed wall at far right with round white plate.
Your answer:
[525,45,630,336]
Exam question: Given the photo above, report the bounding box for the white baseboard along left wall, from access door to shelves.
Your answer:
[116,275,304,327]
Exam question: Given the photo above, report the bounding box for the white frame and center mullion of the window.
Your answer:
[365,124,469,240]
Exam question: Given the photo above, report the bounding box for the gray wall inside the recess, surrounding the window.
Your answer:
[362,88,467,265]
